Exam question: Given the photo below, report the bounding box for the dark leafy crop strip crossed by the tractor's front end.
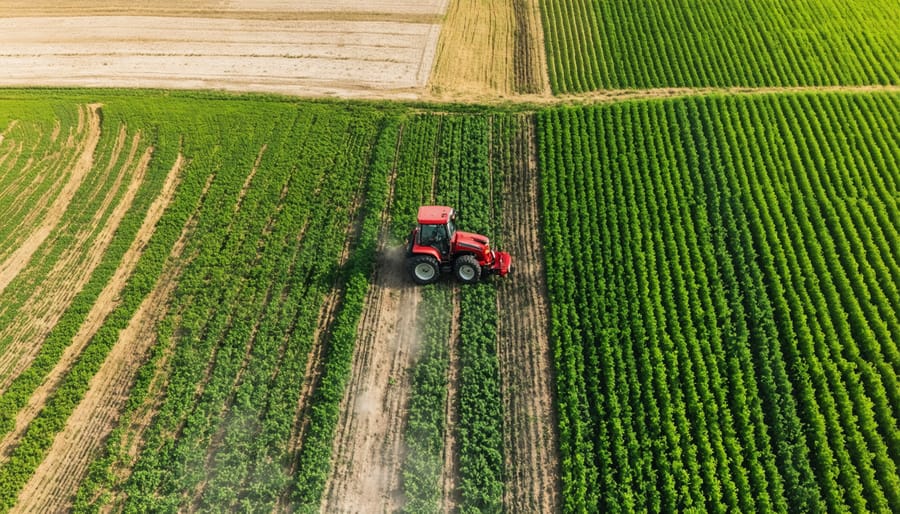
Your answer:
[436,116,504,512]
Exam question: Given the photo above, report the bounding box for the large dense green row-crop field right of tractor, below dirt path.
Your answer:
[539,96,900,511]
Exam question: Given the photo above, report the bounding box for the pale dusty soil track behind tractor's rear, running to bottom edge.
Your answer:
[322,244,421,513]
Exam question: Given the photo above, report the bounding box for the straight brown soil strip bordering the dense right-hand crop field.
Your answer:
[497,114,560,513]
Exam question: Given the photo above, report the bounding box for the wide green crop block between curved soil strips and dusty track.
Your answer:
[61,98,386,510]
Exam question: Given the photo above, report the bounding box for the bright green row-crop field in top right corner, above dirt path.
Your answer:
[541,0,900,93]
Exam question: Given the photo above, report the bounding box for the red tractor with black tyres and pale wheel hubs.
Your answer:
[406,205,511,284]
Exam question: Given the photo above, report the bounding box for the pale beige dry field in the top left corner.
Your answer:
[0,0,448,98]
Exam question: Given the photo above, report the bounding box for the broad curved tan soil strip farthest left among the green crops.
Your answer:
[0,104,100,292]
